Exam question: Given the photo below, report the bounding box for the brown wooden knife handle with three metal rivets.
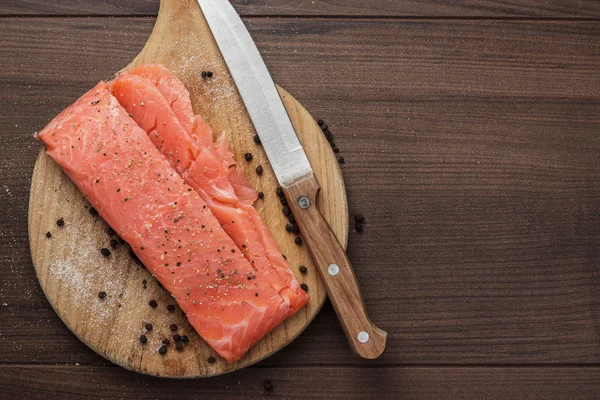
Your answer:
[283,176,387,359]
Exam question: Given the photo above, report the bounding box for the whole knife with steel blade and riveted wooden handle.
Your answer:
[198,0,387,359]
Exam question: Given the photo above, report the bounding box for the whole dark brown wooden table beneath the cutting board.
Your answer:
[0,0,600,400]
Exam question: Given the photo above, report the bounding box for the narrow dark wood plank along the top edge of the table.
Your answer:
[0,0,600,18]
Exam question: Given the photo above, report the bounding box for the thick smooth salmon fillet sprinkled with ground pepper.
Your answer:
[37,82,290,362]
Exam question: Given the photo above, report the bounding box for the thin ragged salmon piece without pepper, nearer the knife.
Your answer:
[111,65,309,316]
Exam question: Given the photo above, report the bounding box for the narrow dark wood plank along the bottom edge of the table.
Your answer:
[0,365,600,400]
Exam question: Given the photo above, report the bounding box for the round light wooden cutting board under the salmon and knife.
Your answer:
[29,0,348,378]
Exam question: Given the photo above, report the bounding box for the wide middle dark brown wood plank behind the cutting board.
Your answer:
[0,19,600,365]
